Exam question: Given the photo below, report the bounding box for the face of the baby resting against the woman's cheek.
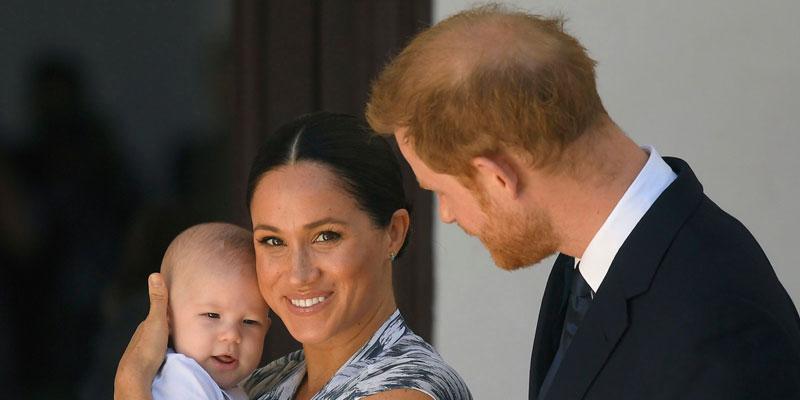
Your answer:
[170,260,269,388]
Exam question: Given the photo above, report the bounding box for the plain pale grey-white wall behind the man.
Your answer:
[433,0,800,399]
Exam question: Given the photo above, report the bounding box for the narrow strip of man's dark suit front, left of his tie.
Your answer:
[528,254,575,399]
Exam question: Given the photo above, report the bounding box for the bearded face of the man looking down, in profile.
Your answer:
[395,128,558,270]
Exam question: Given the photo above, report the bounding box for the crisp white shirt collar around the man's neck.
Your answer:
[576,146,677,292]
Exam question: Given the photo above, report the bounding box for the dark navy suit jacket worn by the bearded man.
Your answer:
[530,158,800,400]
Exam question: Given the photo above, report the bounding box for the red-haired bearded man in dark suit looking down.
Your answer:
[367,3,800,399]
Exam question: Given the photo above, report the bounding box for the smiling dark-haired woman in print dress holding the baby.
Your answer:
[116,113,471,400]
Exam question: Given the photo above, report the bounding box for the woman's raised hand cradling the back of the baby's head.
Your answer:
[114,273,169,400]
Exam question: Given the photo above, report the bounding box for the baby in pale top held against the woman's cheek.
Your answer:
[153,223,270,400]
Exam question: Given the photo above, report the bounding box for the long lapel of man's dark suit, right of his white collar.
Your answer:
[534,157,704,400]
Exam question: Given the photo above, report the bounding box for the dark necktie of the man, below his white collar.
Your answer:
[538,264,593,400]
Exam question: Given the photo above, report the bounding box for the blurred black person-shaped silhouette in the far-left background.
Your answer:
[2,54,137,397]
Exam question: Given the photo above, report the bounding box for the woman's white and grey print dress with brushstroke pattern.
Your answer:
[244,311,472,400]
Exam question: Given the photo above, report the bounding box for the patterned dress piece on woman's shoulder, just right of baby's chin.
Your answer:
[242,350,306,399]
